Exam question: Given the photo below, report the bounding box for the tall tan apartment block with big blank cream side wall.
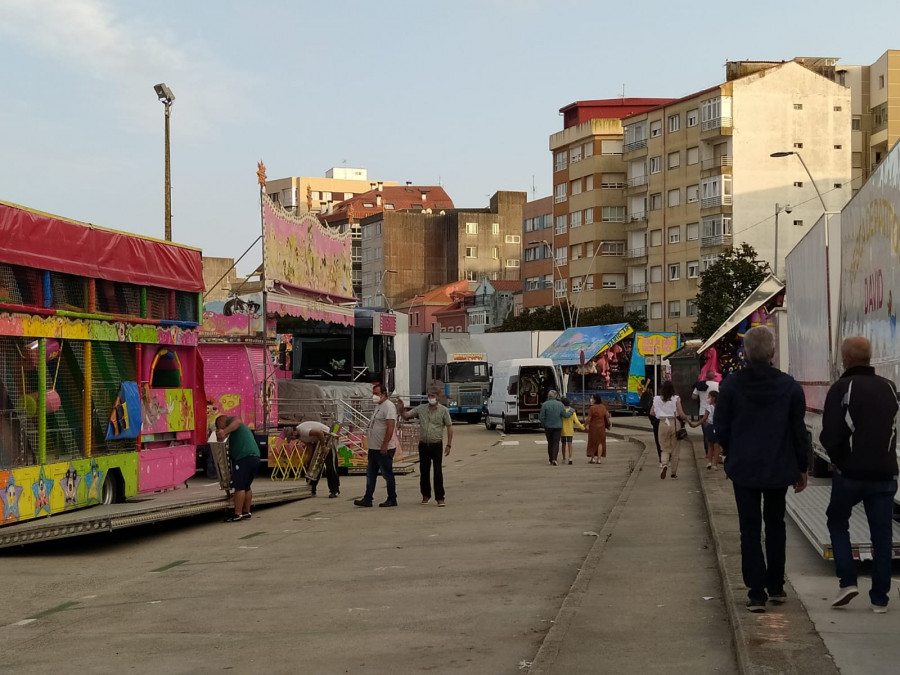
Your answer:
[622,59,851,332]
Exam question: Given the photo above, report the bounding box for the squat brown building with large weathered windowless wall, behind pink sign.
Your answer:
[361,191,526,307]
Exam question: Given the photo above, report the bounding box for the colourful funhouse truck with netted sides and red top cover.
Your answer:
[0,202,206,526]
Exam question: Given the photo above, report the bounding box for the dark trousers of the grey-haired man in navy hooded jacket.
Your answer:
[733,483,787,603]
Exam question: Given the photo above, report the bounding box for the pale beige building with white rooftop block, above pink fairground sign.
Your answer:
[266,166,397,215]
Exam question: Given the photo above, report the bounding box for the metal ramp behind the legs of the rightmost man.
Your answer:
[786,485,900,560]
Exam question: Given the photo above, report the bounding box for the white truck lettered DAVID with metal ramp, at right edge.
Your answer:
[786,139,900,560]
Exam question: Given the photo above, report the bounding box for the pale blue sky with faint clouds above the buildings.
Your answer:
[0,0,900,272]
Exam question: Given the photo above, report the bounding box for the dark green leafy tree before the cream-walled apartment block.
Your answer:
[694,242,767,340]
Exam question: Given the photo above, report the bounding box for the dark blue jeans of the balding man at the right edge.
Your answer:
[826,471,897,606]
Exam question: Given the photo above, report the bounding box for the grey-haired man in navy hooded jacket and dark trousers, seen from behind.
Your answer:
[714,326,809,612]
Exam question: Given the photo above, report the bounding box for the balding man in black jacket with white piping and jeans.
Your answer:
[819,337,898,614]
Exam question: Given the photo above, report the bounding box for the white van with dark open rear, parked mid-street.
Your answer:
[484,359,559,433]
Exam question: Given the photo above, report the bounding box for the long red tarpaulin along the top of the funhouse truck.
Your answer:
[0,202,205,293]
